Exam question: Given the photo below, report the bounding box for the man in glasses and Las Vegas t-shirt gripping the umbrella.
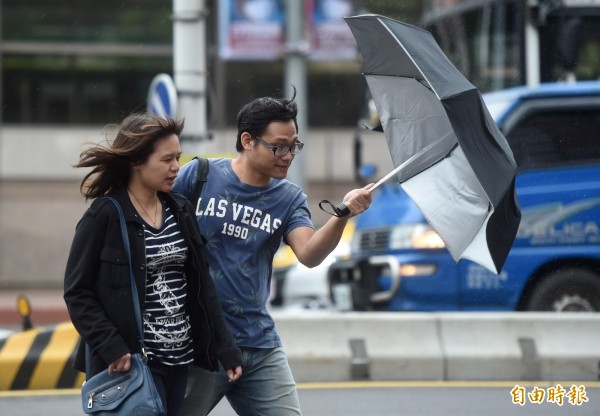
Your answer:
[175,92,372,416]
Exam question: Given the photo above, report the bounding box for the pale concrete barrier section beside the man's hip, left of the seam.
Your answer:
[276,312,444,381]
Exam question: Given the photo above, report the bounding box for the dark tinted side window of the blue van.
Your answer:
[506,108,600,169]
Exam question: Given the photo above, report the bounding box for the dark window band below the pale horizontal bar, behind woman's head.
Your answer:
[2,55,172,124]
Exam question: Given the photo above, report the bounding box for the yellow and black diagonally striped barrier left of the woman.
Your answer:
[0,322,85,391]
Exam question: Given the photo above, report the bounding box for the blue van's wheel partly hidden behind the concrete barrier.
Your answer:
[525,268,600,312]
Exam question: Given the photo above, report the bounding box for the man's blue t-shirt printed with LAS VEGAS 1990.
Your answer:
[174,158,314,348]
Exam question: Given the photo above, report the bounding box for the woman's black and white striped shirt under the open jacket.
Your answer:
[144,201,193,365]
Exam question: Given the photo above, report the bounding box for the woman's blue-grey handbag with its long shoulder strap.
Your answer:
[81,197,166,416]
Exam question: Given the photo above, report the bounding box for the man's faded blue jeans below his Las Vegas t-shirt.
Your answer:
[180,348,301,416]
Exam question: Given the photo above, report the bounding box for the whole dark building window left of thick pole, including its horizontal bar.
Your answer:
[0,0,173,124]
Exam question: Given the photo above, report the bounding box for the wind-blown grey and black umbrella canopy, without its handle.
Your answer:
[346,15,521,273]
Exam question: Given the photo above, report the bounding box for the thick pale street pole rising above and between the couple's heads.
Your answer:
[173,0,210,154]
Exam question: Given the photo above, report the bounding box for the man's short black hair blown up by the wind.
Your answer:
[235,87,298,152]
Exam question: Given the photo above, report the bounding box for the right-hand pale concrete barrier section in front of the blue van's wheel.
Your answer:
[440,313,600,381]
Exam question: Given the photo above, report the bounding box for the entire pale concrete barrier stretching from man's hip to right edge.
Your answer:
[274,312,600,382]
